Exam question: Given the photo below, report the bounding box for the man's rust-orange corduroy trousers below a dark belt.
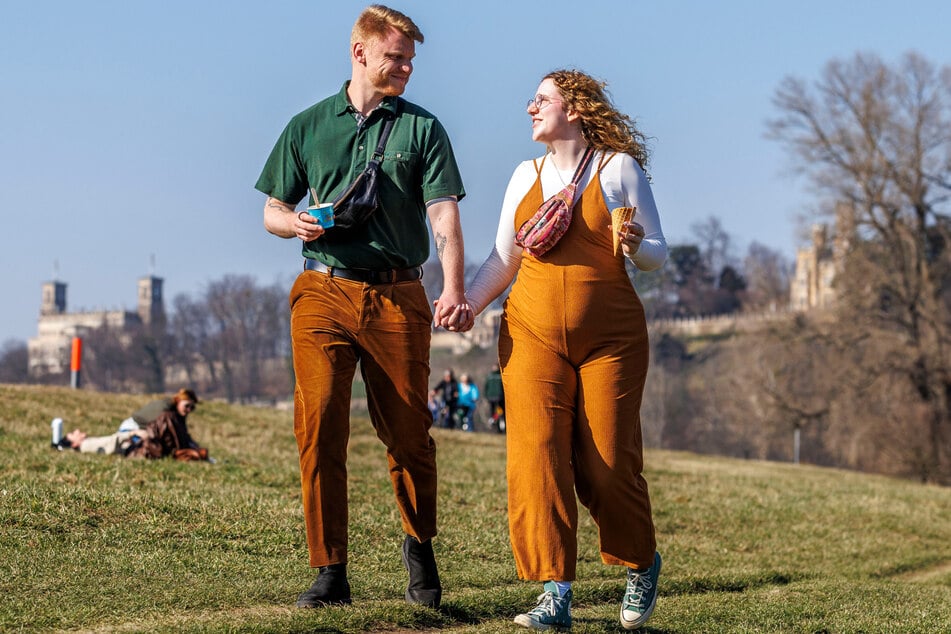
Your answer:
[290,271,436,567]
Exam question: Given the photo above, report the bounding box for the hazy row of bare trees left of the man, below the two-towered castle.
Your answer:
[0,275,293,402]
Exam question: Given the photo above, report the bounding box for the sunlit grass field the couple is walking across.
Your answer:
[0,386,951,633]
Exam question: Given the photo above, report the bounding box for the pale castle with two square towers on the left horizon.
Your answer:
[27,275,165,375]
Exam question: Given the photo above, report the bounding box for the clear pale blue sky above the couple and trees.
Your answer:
[0,0,951,342]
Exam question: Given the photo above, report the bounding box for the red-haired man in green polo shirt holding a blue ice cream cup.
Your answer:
[256,5,471,608]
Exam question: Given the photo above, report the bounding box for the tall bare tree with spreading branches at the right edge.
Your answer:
[769,53,951,482]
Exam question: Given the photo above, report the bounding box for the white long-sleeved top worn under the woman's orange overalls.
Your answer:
[466,152,667,314]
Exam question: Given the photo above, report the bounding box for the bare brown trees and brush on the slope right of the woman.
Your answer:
[644,53,951,484]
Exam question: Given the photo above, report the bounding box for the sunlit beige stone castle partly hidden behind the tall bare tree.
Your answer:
[789,203,855,311]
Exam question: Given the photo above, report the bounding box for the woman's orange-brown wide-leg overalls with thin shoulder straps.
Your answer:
[499,155,655,581]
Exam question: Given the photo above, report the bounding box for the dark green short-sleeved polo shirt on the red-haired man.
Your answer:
[255,82,465,270]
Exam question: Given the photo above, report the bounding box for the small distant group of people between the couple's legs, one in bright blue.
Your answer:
[428,364,505,433]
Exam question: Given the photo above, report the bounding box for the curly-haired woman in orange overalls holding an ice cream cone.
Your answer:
[467,70,667,629]
